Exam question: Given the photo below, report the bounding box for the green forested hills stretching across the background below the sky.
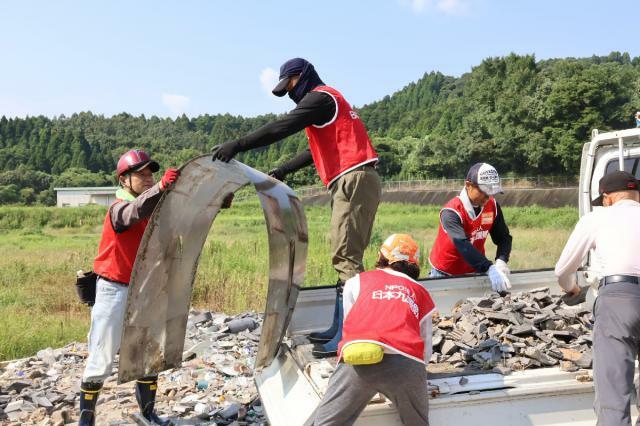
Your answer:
[0,52,640,203]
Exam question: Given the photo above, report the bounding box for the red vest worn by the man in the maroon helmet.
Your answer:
[93,200,149,284]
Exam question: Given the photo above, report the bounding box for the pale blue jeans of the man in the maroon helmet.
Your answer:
[82,277,129,383]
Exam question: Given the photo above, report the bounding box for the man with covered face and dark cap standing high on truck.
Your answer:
[213,58,381,357]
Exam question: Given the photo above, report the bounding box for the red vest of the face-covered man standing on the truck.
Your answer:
[305,86,378,186]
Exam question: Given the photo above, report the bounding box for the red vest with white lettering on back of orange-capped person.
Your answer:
[338,269,435,363]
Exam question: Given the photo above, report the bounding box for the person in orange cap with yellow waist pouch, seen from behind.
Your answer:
[313,234,435,426]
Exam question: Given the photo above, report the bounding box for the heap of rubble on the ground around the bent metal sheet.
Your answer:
[0,312,268,426]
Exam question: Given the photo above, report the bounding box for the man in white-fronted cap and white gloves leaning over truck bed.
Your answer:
[429,163,512,293]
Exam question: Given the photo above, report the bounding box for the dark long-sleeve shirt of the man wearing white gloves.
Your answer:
[440,202,513,272]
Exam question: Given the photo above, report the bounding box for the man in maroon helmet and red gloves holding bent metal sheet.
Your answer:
[79,150,180,426]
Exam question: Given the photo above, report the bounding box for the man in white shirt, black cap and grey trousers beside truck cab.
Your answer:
[555,171,640,425]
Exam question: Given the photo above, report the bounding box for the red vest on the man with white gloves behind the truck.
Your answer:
[429,197,498,275]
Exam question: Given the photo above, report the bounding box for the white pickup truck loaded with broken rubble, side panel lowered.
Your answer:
[255,129,640,426]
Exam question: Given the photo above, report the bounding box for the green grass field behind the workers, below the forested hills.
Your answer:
[0,201,577,360]
